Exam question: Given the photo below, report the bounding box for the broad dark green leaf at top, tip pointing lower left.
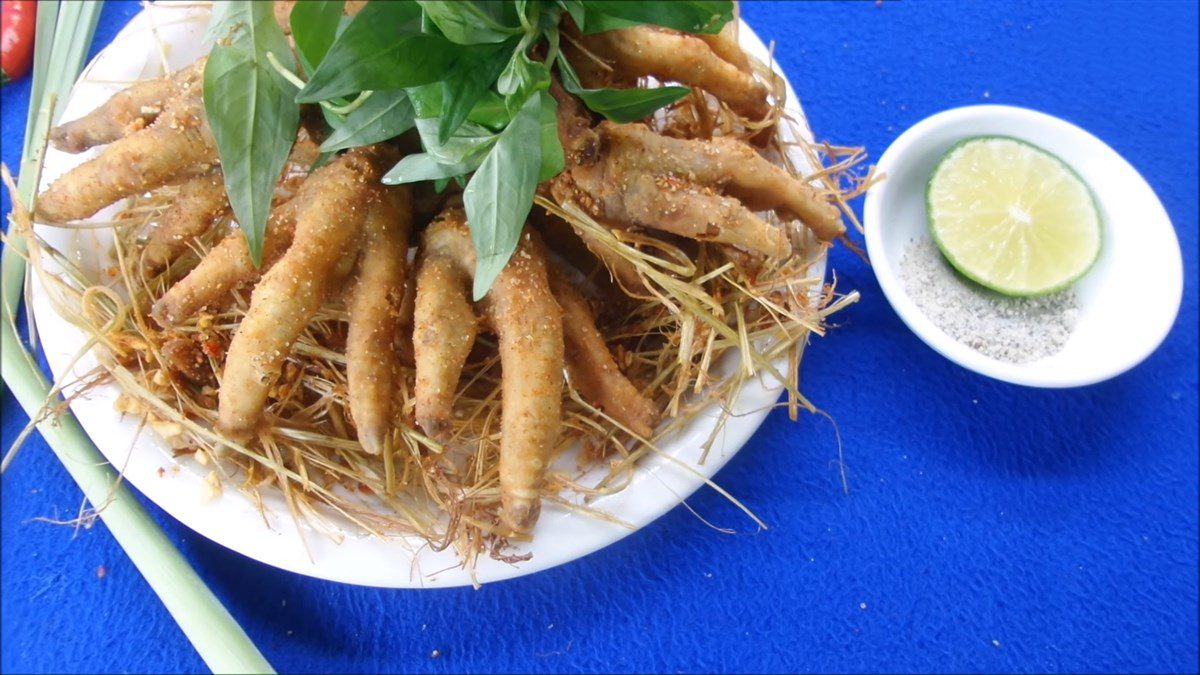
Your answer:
[296,1,463,103]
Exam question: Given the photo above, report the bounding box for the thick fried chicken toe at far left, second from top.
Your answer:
[37,64,217,222]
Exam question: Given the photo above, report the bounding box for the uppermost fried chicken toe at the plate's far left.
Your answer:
[50,59,205,154]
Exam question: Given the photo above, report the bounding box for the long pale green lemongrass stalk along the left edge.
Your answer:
[0,1,274,673]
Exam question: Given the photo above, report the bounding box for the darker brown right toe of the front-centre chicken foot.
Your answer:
[550,271,659,438]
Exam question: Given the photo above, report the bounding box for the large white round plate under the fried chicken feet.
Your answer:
[32,2,824,587]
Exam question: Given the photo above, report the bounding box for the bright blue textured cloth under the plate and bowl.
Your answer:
[0,0,1198,671]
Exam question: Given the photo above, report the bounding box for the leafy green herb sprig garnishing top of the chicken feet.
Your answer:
[205,0,733,294]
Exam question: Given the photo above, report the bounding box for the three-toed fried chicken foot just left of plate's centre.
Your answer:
[139,145,412,453]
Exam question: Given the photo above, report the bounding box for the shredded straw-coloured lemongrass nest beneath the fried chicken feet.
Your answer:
[18,35,871,569]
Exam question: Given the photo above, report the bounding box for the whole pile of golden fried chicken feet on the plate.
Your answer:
[36,17,844,532]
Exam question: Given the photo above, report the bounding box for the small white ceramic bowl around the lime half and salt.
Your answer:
[863,106,1183,387]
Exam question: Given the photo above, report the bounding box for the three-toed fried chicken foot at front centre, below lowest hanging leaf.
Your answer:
[413,207,658,532]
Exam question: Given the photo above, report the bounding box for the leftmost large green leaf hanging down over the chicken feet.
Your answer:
[204,0,300,264]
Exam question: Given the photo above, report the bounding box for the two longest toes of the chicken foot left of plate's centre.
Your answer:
[217,147,412,444]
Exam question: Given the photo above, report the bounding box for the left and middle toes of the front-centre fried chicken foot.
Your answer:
[413,208,563,531]
